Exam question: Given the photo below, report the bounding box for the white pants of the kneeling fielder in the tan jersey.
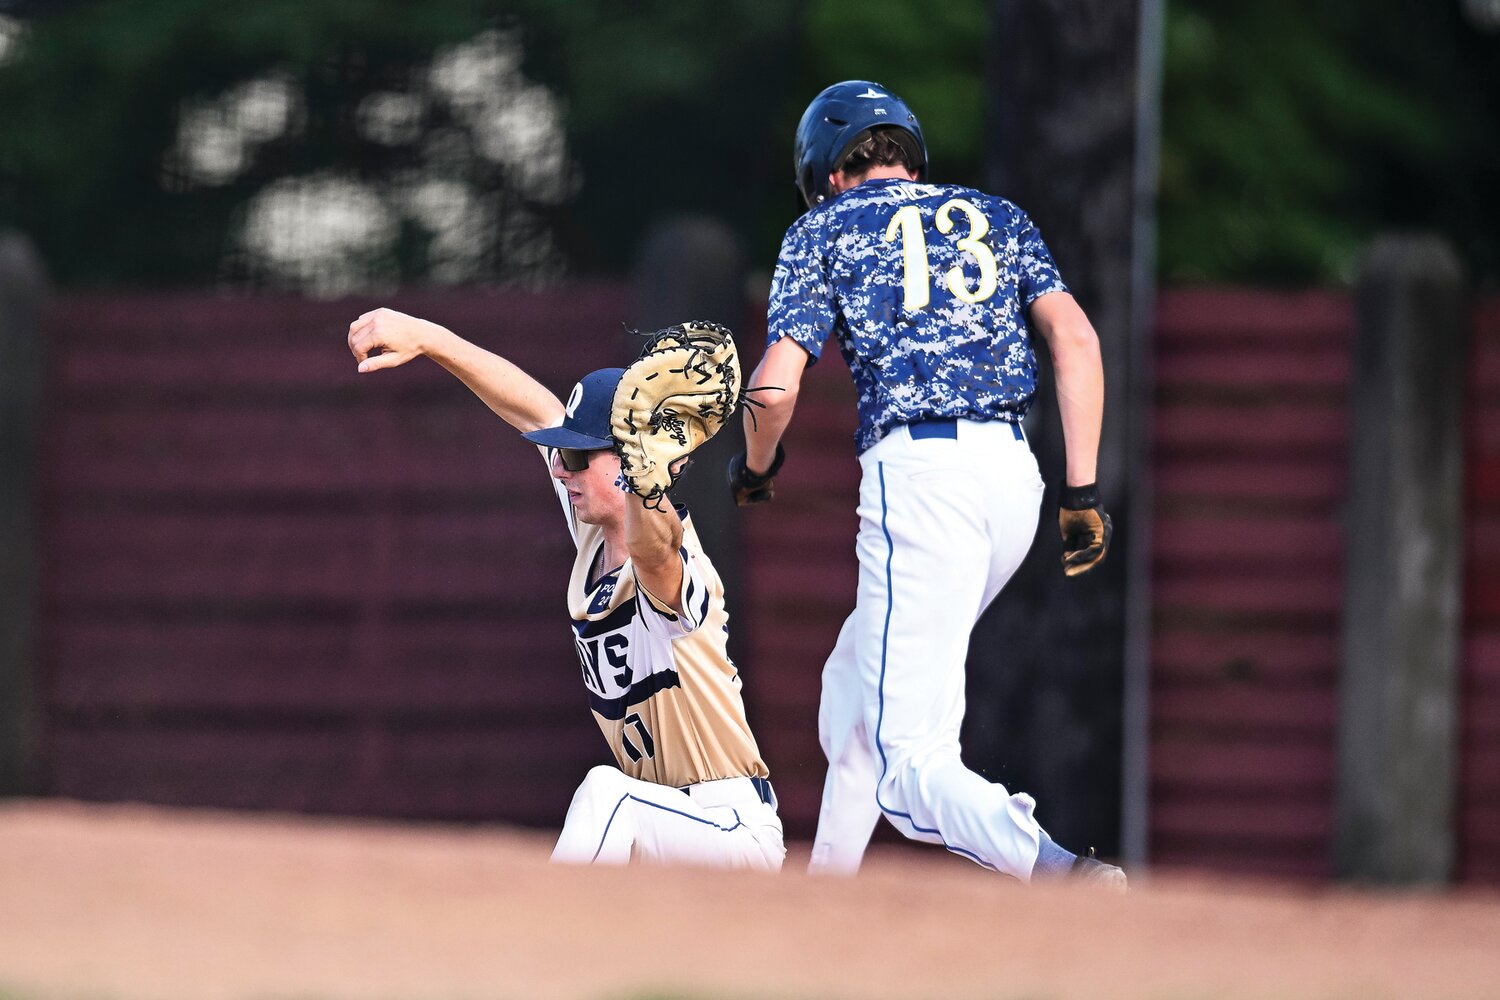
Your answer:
[552,765,786,871]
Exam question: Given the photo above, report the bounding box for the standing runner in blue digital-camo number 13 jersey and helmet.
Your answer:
[729,79,1125,889]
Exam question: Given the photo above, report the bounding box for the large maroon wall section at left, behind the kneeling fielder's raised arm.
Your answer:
[39,288,629,823]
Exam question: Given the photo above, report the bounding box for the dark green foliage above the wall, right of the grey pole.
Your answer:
[1160,0,1500,283]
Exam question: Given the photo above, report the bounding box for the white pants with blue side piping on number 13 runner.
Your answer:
[809,420,1043,882]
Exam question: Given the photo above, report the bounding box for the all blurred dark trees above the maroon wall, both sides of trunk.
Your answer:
[0,0,1500,295]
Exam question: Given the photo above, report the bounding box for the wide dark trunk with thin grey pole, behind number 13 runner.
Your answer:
[978,0,1161,862]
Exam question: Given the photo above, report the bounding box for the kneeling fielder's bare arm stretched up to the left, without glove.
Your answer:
[350,309,563,433]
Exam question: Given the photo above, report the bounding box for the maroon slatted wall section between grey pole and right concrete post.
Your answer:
[1151,291,1353,876]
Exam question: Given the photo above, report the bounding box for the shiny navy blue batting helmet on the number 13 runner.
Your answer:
[792,79,927,208]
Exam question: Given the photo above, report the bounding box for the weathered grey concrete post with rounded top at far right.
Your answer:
[1334,237,1470,885]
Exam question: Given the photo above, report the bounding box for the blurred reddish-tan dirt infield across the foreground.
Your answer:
[0,802,1500,1000]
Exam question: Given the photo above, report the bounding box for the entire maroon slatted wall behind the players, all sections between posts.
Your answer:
[38,286,1500,885]
